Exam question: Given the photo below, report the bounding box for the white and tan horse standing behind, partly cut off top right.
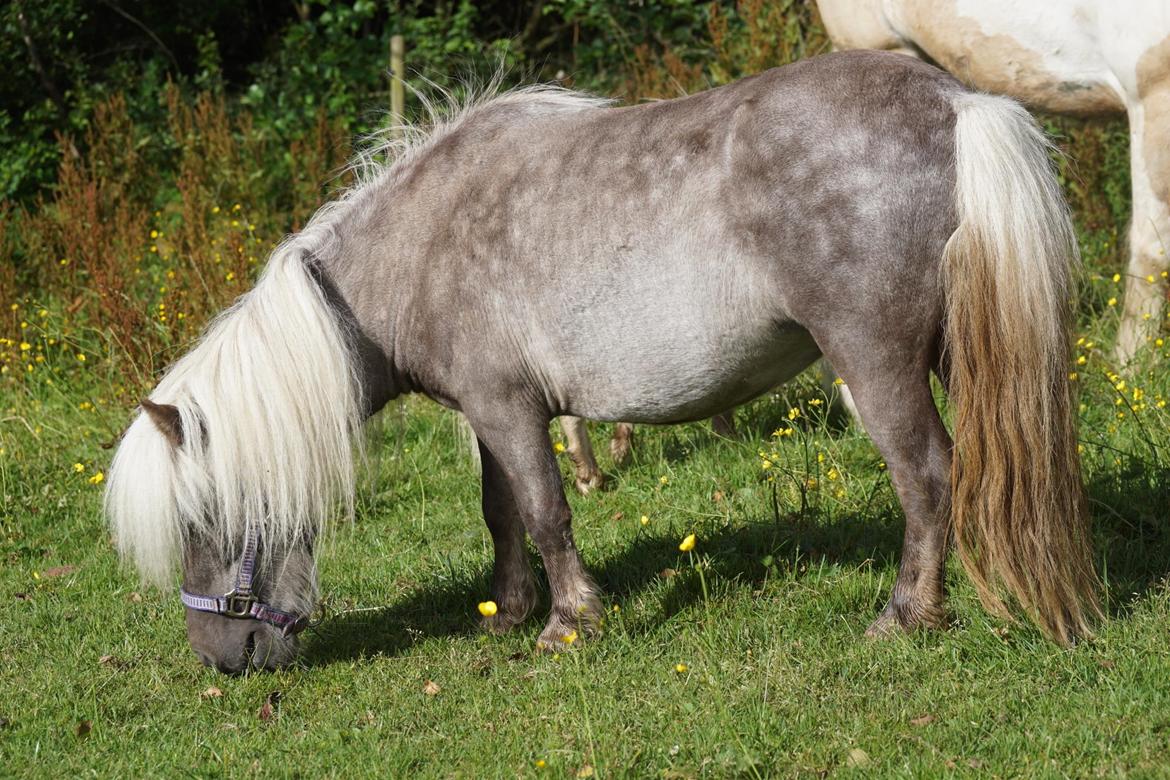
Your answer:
[818,0,1170,364]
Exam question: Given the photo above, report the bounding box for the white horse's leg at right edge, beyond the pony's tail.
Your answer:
[1117,95,1170,366]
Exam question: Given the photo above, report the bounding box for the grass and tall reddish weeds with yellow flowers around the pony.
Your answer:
[0,21,1170,778]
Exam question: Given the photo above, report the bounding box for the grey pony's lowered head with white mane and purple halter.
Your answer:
[105,246,360,672]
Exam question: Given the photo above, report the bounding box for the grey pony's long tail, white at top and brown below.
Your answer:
[943,94,1100,643]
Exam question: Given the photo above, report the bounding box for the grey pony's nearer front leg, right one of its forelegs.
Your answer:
[468,409,601,650]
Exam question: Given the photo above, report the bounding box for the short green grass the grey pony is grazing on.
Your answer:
[0,301,1170,778]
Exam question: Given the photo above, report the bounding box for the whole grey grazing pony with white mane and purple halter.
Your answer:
[105,53,1097,671]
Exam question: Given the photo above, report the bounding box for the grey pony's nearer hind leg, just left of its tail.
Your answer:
[826,346,951,636]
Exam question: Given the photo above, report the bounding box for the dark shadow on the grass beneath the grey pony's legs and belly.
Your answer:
[303,500,902,667]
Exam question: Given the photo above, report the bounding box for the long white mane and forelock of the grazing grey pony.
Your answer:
[105,87,608,585]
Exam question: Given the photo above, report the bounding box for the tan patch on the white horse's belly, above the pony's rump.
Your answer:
[903,0,1126,116]
